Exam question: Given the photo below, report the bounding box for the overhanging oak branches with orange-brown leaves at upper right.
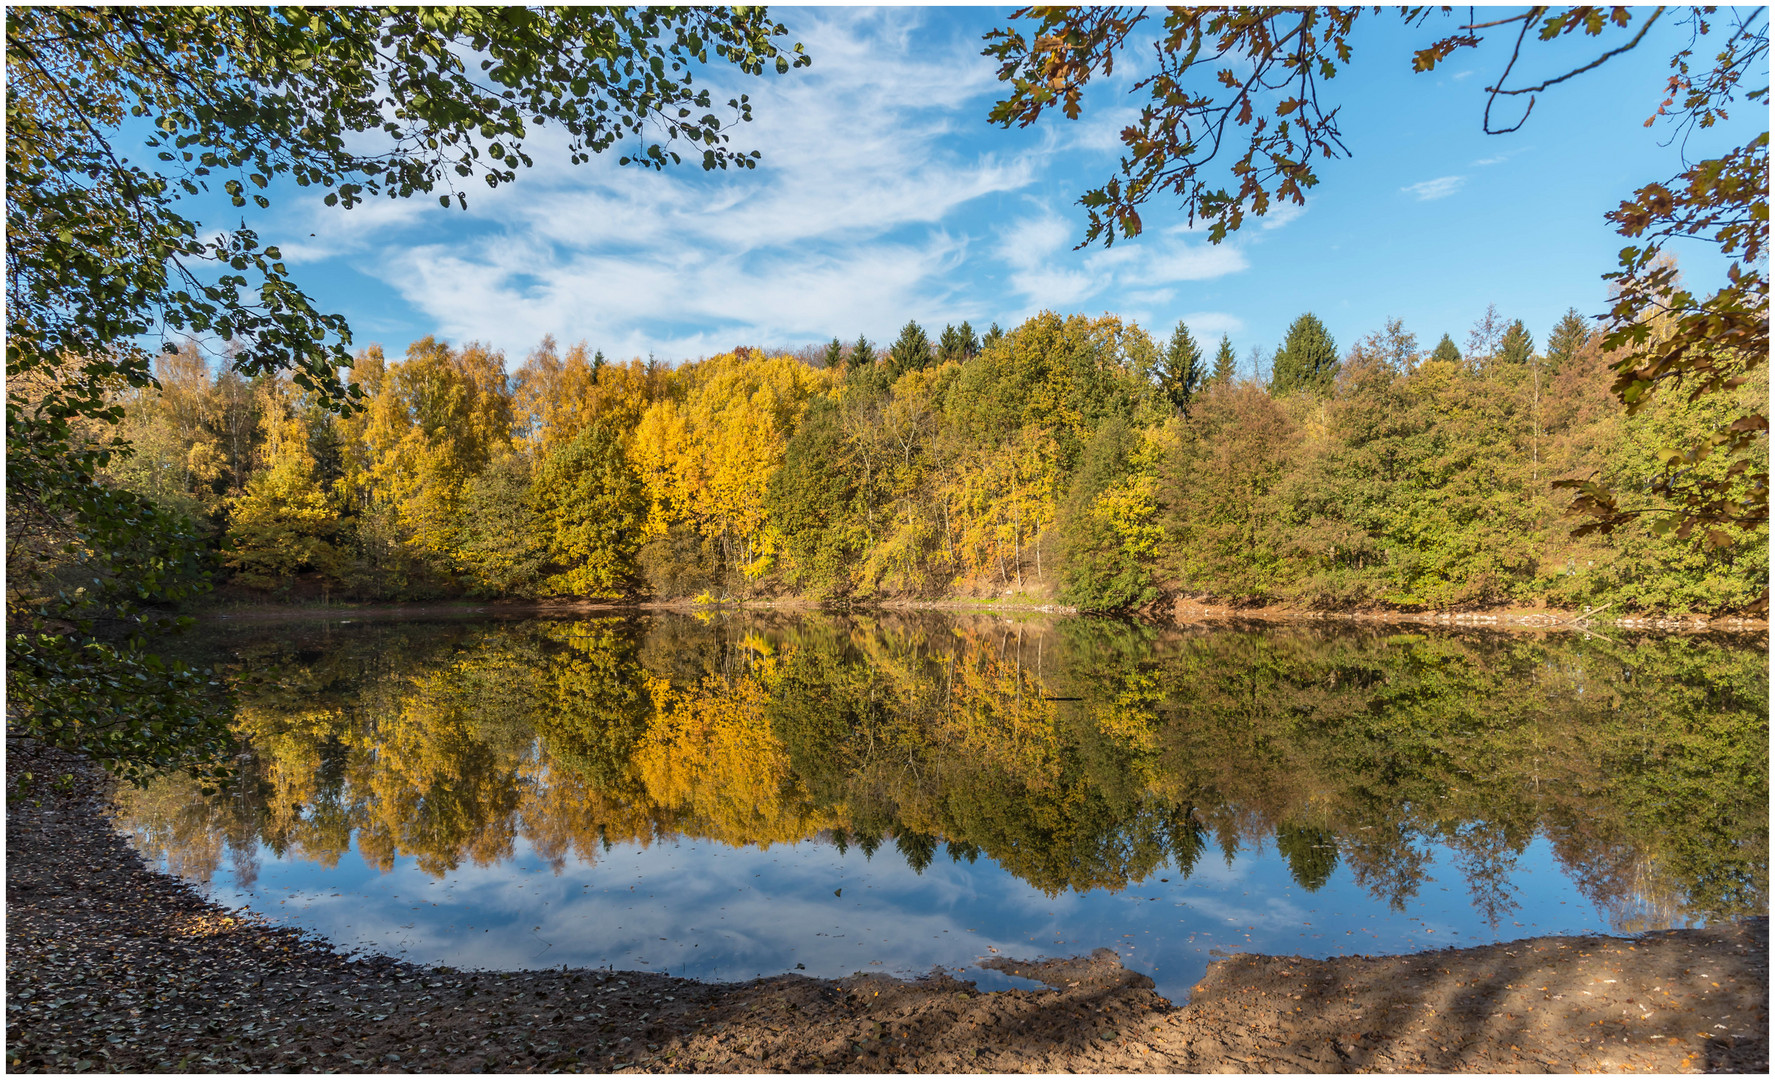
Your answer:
[985,5,1770,545]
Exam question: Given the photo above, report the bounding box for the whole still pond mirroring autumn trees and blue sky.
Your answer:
[121,615,1768,1000]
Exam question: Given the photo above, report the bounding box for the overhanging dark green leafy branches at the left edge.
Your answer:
[5,7,806,781]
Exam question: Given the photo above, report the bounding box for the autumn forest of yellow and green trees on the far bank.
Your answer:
[105,309,1768,615]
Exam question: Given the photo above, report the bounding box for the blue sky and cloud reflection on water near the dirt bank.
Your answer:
[169,827,1608,1000]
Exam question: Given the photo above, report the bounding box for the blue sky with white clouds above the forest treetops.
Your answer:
[231,7,1768,374]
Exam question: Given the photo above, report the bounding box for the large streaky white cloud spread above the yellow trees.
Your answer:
[269,9,1256,362]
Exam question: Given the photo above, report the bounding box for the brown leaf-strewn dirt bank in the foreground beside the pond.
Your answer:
[5,739,1768,1073]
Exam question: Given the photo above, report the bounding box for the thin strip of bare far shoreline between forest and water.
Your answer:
[192,597,1770,634]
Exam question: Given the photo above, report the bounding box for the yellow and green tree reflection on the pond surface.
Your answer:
[124,616,1768,927]
